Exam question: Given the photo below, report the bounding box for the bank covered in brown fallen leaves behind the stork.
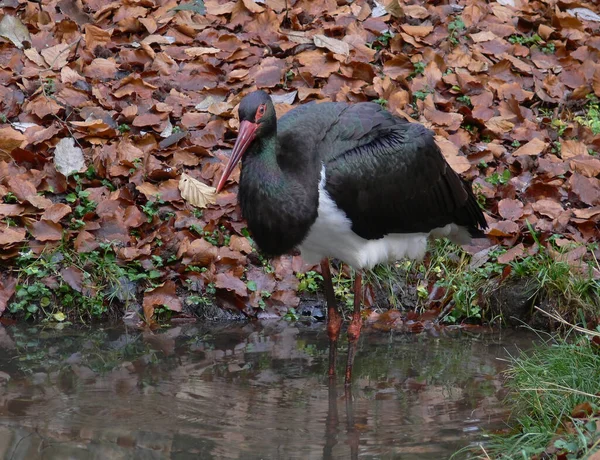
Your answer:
[0,0,600,324]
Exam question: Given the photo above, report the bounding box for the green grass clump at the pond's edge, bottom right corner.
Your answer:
[480,328,600,459]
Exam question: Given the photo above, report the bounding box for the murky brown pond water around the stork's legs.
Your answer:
[0,322,530,459]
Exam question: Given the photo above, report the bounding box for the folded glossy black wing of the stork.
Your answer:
[321,103,487,239]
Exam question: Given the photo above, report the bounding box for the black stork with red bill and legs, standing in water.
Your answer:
[217,91,487,385]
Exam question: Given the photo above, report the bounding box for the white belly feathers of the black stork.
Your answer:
[299,167,470,269]
